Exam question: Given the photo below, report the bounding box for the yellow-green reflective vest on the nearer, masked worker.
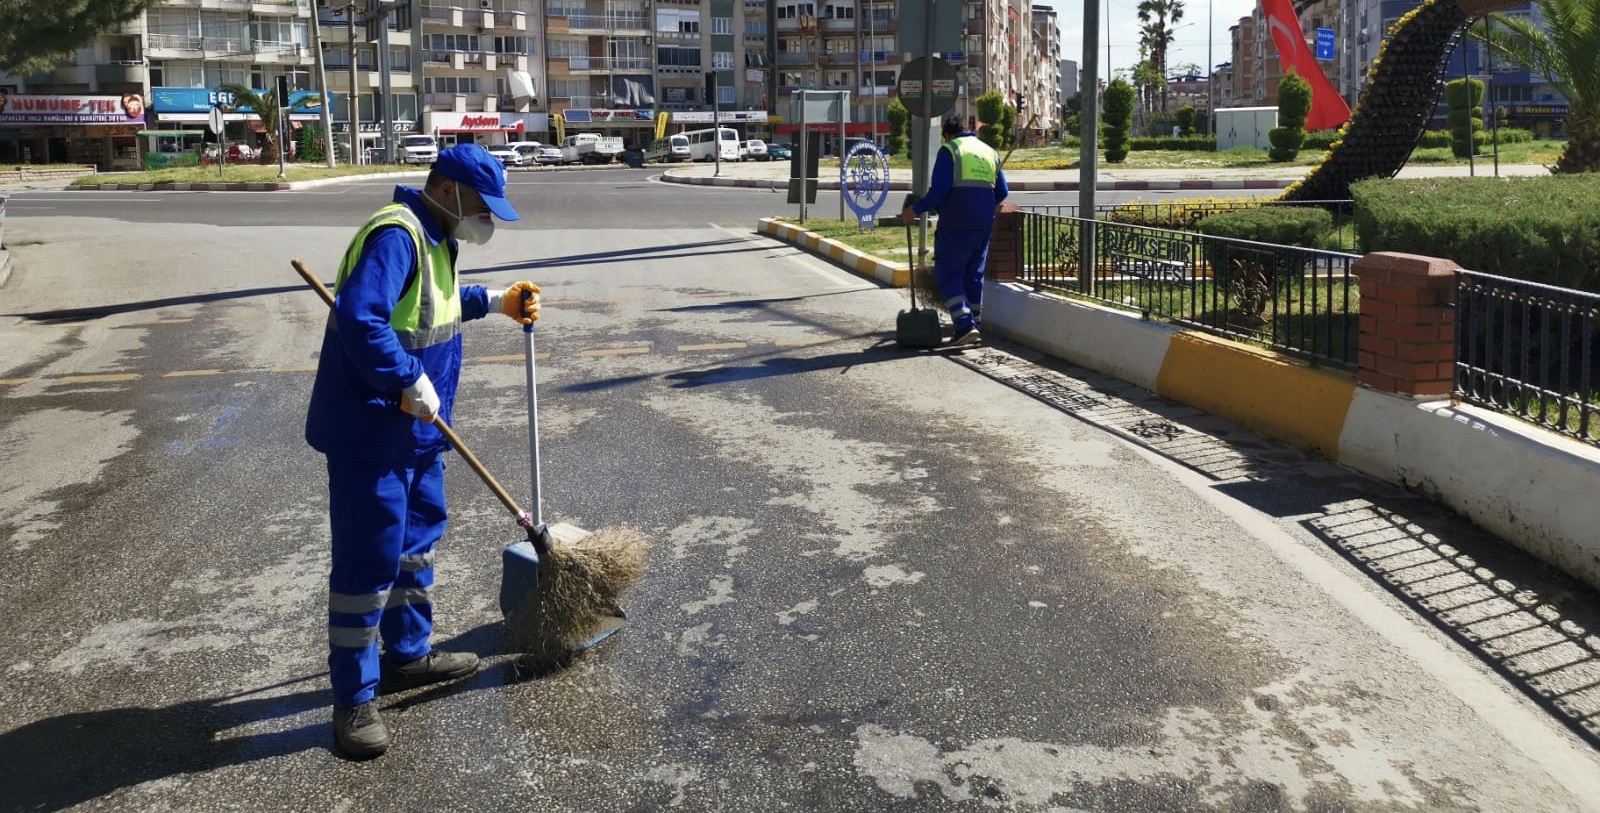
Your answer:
[333,203,461,350]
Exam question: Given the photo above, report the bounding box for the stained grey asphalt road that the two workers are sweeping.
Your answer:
[0,170,1600,811]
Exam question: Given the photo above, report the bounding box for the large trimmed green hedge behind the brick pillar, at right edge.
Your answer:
[1350,174,1600,291]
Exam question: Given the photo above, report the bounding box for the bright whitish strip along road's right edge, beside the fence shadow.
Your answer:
[1130,443,1600,799]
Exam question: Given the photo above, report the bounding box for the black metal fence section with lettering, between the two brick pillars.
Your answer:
[1019,211,1360,368]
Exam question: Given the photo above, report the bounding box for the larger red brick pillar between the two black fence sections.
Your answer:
[1352,251,1461,397]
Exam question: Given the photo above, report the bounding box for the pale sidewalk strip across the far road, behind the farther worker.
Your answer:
[662,160,1549,192]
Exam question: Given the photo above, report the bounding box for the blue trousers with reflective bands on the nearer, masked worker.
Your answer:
[328,455,445,707]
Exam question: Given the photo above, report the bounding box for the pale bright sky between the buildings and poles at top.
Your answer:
[1032,0,1256,78]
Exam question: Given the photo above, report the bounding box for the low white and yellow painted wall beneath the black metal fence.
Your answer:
[984,280,1600,587]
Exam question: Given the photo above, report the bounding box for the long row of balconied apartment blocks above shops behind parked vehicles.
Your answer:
[0,0,1061,170]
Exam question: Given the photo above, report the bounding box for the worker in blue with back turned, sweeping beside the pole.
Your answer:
[901,118,1010,346]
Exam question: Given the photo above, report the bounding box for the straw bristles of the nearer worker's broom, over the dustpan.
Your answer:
[504,525,650,674]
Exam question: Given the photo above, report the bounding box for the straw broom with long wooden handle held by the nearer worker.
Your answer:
[290,259,650,674]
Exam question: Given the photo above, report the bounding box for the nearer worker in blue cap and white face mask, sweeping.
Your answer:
[306,144,539,759]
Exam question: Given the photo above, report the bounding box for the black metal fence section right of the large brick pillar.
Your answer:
[1454,270,1600,445]
